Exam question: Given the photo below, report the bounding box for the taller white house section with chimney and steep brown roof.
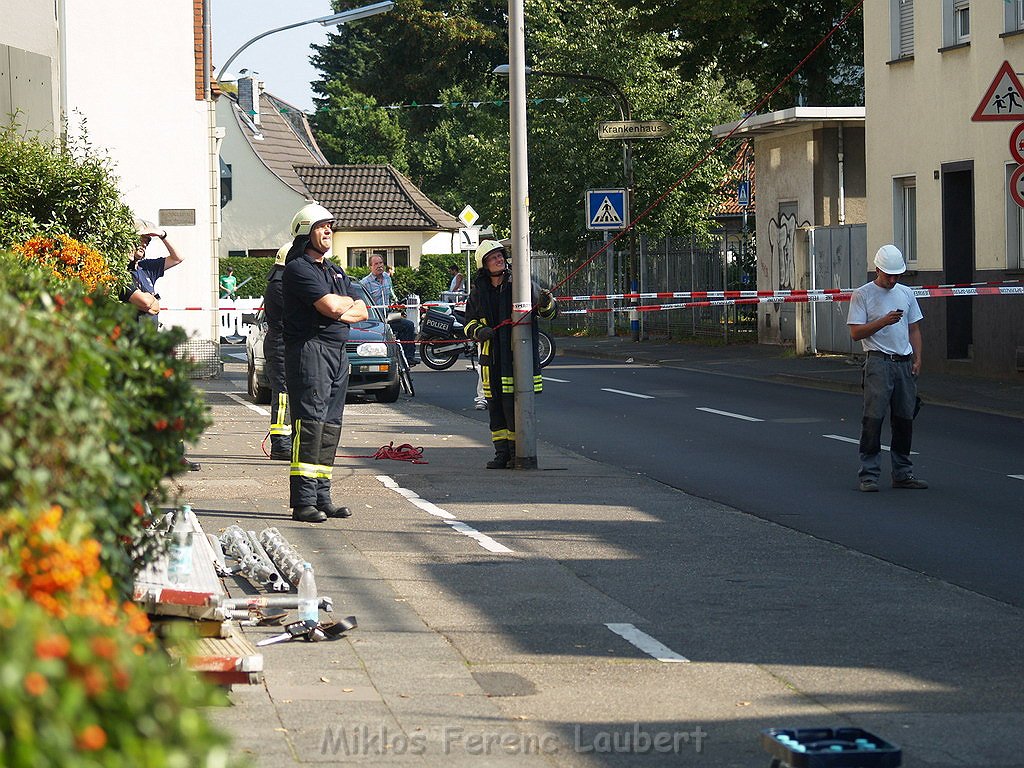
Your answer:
[217,76,327,257]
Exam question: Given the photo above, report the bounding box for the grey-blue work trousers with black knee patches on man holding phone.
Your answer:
[858,354,918,481]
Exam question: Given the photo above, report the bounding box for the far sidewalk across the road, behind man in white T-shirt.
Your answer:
[555,336,1024,419]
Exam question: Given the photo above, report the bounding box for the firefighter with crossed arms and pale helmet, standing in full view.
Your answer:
[282,204,367,522]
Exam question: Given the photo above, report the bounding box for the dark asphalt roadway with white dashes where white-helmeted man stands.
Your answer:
[405,356,1024,606]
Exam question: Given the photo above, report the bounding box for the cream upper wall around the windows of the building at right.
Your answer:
[864,0,1024,270]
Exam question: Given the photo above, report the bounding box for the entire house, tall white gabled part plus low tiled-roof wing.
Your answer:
[217,76,461,267]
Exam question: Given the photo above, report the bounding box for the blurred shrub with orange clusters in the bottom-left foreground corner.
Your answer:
[0,507,234,768]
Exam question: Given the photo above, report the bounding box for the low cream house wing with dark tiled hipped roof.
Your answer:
[295,165,462,268]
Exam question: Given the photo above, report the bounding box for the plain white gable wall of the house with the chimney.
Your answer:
[217,96,306,258]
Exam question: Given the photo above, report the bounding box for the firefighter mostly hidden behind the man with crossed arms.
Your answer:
[263,244,292,462]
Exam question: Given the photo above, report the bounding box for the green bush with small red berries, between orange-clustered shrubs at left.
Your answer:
[0,256,208,592]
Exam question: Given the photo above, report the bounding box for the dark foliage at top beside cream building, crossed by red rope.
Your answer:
[612,0,864,109]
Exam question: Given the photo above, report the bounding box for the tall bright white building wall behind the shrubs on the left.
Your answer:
[66,0,218,340]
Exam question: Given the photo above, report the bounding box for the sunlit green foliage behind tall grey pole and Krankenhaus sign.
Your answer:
[313,0,749,259]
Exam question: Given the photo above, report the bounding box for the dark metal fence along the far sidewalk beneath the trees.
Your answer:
[532,233,757,342]
